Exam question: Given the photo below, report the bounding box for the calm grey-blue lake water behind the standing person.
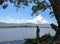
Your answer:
[0,28,55,42]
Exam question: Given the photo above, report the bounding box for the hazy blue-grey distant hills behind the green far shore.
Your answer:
[0,22,50,27]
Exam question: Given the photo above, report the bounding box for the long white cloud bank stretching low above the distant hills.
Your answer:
[6,15,48,24]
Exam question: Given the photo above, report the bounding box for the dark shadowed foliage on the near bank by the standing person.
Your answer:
[24,34,54,44]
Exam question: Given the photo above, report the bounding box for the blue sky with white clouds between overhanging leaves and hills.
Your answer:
[0,3,56,24]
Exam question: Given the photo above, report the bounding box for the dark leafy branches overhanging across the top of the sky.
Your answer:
[0,0,52,15]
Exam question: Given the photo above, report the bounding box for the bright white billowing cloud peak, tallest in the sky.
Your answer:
[28,15,48,24]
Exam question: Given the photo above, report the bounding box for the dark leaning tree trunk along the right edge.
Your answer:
[49,0,60,40]
